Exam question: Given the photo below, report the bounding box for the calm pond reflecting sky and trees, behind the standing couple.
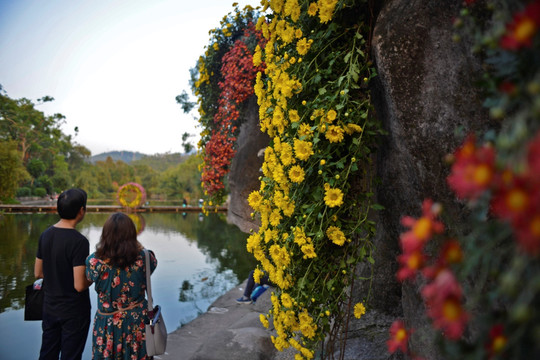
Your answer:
[0,213,255,360]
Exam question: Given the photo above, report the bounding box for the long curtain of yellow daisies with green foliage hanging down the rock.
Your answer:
[247,0,381,359]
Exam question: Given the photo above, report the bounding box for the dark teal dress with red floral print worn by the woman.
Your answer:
[86,250,157,360]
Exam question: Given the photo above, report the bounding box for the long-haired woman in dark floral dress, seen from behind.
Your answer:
[86,213,157,360]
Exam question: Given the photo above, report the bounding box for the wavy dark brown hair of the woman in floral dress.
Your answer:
[96,213,142,268]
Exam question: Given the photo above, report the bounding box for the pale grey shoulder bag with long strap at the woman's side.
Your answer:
[144,249,167,356]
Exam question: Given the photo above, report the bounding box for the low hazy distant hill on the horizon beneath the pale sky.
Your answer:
[90,151,188,171]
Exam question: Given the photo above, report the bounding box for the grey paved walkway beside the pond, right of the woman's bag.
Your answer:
[158,281,293,360]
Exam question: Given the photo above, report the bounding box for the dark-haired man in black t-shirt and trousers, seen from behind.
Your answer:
[34,189,91,360]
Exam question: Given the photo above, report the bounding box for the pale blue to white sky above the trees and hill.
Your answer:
[0,0,259,155]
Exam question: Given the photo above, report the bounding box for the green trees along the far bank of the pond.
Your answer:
[0,85,202,203]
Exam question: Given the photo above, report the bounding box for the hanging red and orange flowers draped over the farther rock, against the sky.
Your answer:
[194,6,264,205]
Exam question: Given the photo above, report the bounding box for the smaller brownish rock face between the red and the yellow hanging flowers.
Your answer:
[227,97,269,232]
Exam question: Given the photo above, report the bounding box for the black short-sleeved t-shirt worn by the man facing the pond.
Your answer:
[37,226,90,318]
